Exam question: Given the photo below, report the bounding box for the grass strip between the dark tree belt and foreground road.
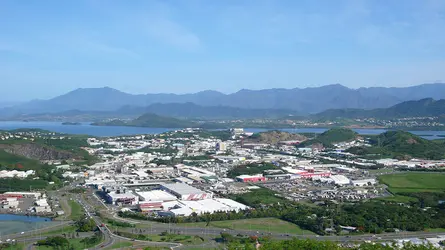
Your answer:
[181,218,314,235]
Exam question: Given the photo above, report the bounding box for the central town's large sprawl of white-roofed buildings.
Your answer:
[81,129,390,208]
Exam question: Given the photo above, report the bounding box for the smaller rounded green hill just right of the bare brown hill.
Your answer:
[300,128,358,147]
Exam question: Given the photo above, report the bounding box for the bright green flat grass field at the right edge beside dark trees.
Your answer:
[379,173,445,194]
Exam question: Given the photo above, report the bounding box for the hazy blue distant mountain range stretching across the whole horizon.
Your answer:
[0,83,445,117]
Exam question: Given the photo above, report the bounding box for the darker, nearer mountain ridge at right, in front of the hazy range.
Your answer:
[313,98,445,119]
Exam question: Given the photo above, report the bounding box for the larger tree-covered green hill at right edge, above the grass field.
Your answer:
[348,131,445,160]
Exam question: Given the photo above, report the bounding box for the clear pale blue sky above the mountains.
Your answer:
[0,0,445,101]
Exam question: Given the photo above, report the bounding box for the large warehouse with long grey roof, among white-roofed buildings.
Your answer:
[161,183,213,201]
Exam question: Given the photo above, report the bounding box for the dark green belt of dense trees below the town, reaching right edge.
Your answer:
[119,196,445,235]
